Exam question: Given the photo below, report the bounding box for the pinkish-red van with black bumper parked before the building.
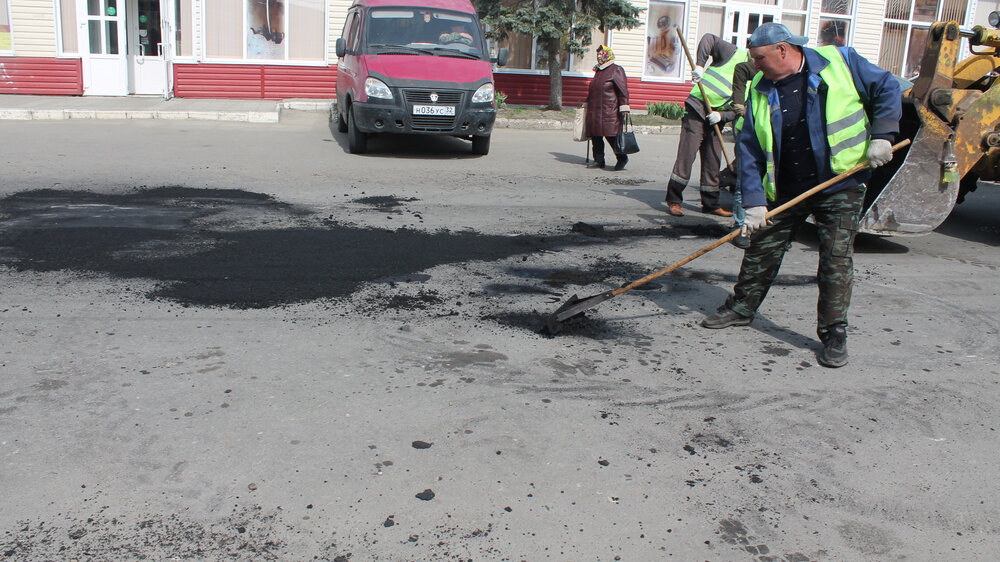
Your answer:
[337,0,507,154]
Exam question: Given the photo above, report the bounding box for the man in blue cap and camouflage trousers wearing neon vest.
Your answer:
[702,23,902,367]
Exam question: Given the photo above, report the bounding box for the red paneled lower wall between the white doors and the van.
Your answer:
[174,64,337,100]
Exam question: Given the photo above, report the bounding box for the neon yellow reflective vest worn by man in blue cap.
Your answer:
[750,46,868,201]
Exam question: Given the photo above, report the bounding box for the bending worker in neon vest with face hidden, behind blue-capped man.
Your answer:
[666,33,747,217]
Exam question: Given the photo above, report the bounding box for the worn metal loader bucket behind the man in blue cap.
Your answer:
[860,98,960,235]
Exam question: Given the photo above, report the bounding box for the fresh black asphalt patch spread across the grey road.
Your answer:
[0,187,725,309]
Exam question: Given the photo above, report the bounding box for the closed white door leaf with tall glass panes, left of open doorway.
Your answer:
[77,0,128,96]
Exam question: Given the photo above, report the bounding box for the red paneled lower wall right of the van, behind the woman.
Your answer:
[493,73,691,109]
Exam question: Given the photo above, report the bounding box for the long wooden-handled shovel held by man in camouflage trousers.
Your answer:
[544,139,910,336]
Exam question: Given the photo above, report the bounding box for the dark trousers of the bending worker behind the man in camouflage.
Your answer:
[667,112,720,211]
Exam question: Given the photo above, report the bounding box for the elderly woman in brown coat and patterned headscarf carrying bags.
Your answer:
[587,45,629,170]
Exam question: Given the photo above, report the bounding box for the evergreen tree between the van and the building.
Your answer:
[475,0,642,109]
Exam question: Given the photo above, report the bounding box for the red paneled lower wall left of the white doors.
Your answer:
[0,57,83,96]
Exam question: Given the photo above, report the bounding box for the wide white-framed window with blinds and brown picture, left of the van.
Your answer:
[204,0,326,62]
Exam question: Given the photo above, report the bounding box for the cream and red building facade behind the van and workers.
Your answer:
[0,0,1000,105]
